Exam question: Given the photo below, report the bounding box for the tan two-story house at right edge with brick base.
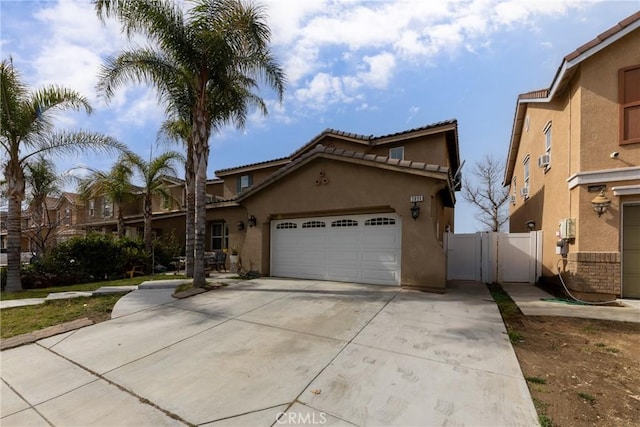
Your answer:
[504,12,640,299]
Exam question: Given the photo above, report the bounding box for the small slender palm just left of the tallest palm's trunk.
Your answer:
[122,151,184,253]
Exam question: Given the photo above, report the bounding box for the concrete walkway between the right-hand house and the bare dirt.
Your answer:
[502,283,640,323]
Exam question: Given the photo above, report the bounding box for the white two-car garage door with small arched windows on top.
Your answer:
[271,214,402,285]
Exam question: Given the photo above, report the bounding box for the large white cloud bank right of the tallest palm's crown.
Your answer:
[269,0,583,112]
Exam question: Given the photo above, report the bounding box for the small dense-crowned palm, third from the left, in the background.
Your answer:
[78,160,135,238]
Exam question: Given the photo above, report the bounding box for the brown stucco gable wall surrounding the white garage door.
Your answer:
[241,158,446,290]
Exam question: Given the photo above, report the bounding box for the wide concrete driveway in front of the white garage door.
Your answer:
[0,278,538,427]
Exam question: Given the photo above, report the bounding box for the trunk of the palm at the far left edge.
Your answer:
[5,160,24,292]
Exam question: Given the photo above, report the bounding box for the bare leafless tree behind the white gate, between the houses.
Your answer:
[462,155,509,231]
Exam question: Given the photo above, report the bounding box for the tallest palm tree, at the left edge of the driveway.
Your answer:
[96,0,285,287]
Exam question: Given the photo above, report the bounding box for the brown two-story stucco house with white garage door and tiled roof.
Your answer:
[153,120,460,292]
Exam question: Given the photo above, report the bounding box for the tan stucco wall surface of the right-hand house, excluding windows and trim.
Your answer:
[510,31,640,290]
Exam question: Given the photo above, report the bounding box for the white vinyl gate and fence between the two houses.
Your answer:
[446,231,542,283]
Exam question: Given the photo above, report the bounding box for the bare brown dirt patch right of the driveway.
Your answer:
[505,312,640,426]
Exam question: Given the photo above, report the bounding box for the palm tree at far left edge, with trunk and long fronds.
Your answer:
[0,59,124,292]
